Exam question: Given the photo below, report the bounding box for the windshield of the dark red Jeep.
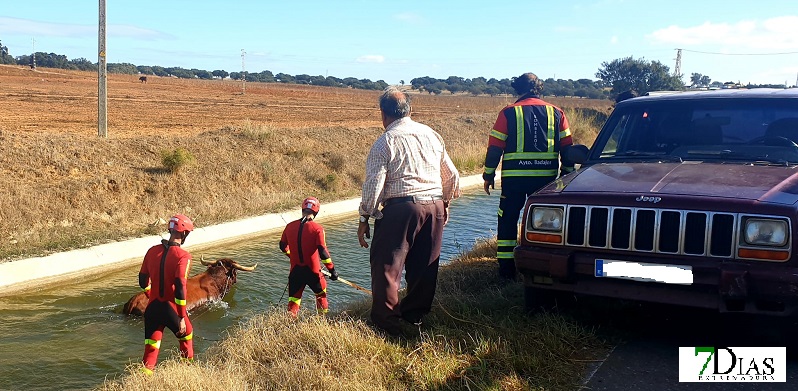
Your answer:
[590,93,798,165]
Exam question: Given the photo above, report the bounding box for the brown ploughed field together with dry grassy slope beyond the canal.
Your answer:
[0,65,610,261]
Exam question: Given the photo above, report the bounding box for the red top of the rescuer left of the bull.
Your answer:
[139,240,191,318]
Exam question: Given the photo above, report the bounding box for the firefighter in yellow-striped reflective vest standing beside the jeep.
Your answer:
[482,73,574,280]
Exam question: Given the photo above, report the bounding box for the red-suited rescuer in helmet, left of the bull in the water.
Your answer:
[139,214,194,374]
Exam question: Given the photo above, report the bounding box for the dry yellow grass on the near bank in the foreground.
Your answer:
[100,241,604,391]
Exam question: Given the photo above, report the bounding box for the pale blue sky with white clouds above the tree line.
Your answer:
[0,0,798,85]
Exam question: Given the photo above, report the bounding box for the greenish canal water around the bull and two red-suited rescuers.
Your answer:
[0,189,499,390]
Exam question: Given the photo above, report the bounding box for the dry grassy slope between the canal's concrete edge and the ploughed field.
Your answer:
[0,116,490,260]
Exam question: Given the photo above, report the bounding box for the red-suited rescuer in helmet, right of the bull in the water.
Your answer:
[280,197,338,316]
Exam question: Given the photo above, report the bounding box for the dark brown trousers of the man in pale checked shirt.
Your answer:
[370,200,444,335]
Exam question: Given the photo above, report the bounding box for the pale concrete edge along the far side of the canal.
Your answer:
[0,175,483,296]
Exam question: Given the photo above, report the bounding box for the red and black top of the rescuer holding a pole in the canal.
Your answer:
[280,219,335,273]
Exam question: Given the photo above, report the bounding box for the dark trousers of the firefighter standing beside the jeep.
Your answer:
[496,177,554,278]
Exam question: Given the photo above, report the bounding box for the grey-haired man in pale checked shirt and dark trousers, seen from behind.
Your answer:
[358,87,460,336]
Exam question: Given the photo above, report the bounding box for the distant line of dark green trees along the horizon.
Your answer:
[0,42,785,99]
